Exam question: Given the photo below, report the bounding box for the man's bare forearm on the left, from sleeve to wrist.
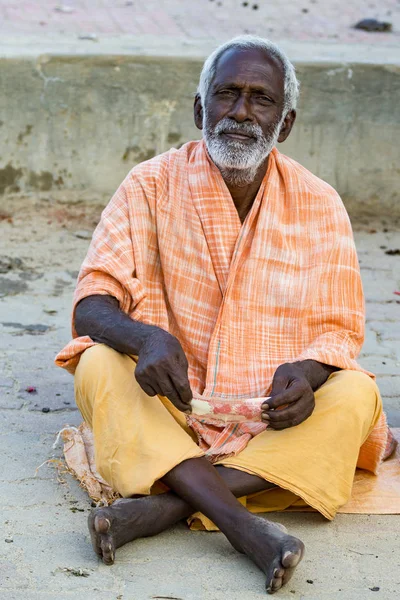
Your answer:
[75,295,159,355]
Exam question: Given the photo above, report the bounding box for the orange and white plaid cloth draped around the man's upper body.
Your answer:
[56,141,387,470]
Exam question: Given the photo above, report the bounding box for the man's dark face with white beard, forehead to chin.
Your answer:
[196,49,294,169]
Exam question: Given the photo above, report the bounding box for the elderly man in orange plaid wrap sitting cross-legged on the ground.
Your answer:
[57,36,386,593]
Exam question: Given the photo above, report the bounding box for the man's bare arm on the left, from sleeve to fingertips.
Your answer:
[75,295,192,412]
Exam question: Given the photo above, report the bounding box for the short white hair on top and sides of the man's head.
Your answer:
[197,35,300,115]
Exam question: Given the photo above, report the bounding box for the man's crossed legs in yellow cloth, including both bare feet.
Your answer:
[75,345,382,593]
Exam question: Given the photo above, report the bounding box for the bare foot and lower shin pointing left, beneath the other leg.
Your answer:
[88,494,193,565]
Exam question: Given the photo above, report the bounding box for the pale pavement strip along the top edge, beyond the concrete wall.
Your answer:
[0,0,400,45]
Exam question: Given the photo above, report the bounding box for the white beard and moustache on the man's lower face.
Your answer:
[203,110,285,187]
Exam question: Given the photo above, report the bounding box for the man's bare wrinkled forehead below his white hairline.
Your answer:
[211,48,285,98]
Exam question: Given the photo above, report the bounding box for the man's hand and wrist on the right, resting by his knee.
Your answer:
[262,360,339,429]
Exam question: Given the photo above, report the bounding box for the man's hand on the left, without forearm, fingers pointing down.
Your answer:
[135,329,193,412]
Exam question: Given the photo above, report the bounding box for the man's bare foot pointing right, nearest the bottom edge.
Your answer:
[226,515,304,594]
